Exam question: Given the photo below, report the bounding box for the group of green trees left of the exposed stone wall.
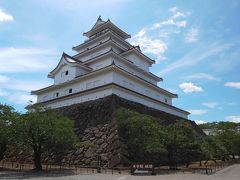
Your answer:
[0,104,80,170]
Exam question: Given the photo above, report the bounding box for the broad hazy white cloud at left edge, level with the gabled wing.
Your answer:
[0,47,57,73]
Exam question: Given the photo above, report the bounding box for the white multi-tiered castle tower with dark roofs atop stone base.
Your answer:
[31,17,189,119]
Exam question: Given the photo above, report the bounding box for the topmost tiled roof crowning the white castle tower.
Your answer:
[83,17,131,39]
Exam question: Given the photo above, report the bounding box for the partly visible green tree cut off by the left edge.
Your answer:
[0,104,20,161]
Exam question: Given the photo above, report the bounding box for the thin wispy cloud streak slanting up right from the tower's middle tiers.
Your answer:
[158,42,233,76]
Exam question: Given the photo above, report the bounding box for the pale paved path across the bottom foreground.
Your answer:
[0,164,240,180]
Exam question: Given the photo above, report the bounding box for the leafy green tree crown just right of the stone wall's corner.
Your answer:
[116,108,166,161]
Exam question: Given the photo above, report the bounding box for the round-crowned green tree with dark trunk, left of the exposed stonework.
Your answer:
[18,105,78,170]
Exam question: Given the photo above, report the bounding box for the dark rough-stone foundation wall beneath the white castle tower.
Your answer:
[3,95,204,168]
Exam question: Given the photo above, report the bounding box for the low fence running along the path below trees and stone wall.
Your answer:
[0,161,239,174]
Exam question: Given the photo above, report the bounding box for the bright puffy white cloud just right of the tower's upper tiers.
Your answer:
[131,7,188,62]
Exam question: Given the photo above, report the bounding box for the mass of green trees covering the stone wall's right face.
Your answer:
[116,108,201,166]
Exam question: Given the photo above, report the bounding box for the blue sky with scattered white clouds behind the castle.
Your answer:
[0,0,240,122]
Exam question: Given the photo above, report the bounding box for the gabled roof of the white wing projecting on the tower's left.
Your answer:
[48,52,92,78]
